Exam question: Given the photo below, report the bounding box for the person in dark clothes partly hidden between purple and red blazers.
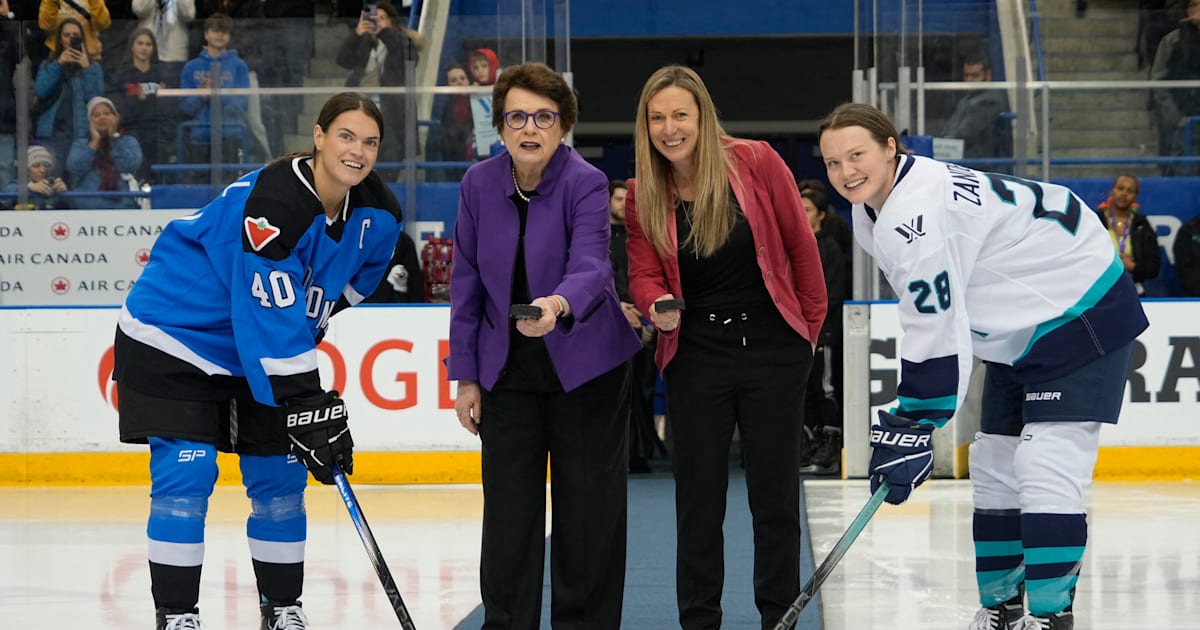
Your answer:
[608,180,666,473]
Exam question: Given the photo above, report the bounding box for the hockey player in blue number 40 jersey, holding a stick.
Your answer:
[113,92,401,630]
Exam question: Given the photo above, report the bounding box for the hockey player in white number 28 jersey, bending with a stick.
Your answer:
[818,103,1147,630]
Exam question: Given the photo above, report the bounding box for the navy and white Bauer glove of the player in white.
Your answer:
[870,410,934,505]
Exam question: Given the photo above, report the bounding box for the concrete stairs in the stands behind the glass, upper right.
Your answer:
[1037,0,1159,178]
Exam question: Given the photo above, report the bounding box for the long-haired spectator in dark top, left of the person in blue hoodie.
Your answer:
[108,26,171,181]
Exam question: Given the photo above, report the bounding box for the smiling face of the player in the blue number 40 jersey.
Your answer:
[312,109,379,188]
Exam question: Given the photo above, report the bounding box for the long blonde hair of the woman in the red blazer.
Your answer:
[634,66,737,257]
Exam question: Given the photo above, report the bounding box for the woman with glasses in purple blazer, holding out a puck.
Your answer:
[446,64,641,630]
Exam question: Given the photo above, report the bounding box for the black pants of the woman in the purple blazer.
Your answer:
[479,365,629,630]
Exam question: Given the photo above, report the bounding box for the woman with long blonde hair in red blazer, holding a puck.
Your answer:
[625,66,826,630]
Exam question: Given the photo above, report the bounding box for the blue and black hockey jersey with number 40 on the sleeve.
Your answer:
[113,157,402,406]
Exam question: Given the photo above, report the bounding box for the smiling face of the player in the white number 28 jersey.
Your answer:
[821,125,896,210]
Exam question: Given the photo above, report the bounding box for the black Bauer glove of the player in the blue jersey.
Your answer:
[283,391,354,484]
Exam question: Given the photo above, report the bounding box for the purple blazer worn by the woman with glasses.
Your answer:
[446,145,642,391]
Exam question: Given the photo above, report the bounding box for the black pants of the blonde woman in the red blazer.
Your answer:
[664,307,812,630]
